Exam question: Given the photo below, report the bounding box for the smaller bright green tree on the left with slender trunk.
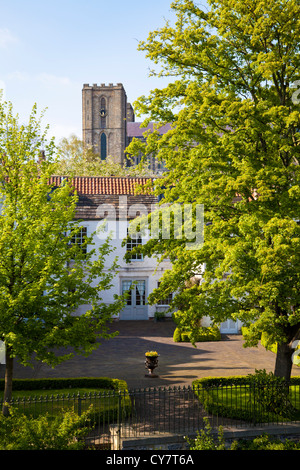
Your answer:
[0,104,123,413]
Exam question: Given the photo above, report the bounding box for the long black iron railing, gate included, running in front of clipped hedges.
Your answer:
[0,384,300,448]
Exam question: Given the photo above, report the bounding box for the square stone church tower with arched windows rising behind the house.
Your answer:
[82,83,134,164]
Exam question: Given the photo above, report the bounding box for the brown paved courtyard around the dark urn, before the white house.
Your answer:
[0,321,300,388]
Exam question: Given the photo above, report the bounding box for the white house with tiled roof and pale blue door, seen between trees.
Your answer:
[52,176,170,320]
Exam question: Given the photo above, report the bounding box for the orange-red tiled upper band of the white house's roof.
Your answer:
[50,176,151,195]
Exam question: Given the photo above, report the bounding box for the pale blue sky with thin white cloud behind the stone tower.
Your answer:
[0,0,179,142]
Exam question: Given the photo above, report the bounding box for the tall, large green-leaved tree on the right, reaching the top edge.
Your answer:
[127,0,300,380]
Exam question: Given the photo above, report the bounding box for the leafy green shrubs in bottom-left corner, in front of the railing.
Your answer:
[0,409,89,450]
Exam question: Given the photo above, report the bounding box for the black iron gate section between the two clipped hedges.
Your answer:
[85,387,207,449]
